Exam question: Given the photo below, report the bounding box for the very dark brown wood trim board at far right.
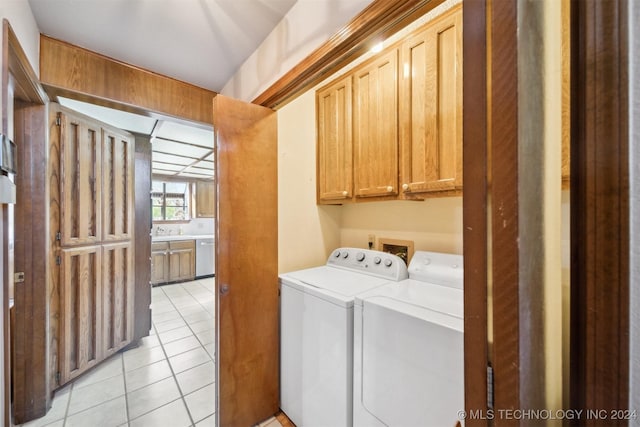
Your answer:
[571,0,636,426]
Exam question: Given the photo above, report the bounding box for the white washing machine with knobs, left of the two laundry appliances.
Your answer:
[280,248,408,427]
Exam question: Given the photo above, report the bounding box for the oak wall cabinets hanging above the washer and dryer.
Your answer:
[316,6,462,204]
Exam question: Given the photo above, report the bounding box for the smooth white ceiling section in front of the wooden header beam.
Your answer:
[29,0,296,92]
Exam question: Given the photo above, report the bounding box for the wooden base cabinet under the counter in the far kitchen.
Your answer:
[151,240,196,285]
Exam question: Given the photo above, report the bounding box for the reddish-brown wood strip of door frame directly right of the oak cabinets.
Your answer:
[462,0,490,427]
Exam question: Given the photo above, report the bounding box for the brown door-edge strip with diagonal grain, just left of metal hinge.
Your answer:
[490,1,520,426]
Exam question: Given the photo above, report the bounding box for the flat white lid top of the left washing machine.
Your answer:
[280,266,396,306]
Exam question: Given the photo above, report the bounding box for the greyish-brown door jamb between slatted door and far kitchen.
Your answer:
[133,135,152,341]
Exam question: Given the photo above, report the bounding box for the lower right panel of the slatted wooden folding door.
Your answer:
[101,242,135,358]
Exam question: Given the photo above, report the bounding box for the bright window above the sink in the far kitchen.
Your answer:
[151,181,190,221]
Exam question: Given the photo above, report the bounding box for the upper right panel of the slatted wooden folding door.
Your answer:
[102,128,135,241]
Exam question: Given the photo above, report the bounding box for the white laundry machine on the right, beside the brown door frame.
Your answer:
[353,251,464,427]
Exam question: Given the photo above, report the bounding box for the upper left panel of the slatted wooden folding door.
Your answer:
[58,113,102,246]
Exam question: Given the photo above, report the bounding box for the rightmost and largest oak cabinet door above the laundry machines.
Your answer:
[400,8,462,196]
